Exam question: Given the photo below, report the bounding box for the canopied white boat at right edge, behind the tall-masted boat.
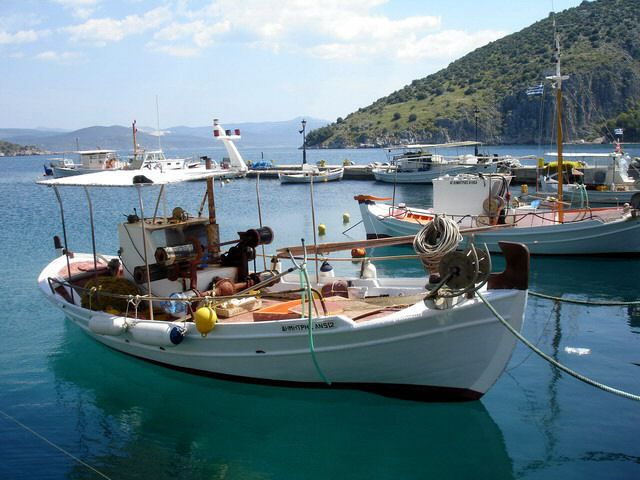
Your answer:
[540,145,640,207]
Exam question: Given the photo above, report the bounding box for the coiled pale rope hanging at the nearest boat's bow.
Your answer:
[413,215,462,274]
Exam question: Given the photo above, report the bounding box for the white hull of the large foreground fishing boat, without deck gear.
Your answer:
[40,256,527,401]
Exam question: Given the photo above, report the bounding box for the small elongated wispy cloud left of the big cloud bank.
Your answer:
[62,6,172,46]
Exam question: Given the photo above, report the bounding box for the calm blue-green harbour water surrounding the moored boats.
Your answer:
[0,145,640,479]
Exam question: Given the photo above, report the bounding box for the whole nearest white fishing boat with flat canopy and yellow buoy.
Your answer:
[38,171,529,401]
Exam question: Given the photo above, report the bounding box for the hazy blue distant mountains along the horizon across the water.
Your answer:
[0,117,329,151]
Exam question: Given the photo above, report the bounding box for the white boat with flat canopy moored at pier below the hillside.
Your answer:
[372,142,500,183]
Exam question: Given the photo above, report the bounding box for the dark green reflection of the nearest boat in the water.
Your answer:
[50,323,513,479]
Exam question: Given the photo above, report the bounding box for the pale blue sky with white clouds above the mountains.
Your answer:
[0,0,580,129]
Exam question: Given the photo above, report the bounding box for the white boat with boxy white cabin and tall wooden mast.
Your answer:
[355,33,640,255]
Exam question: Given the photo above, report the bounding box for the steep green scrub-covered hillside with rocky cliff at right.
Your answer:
[307,0,640,148]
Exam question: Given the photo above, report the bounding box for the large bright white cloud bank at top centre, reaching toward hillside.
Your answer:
[161,0,504,62]
